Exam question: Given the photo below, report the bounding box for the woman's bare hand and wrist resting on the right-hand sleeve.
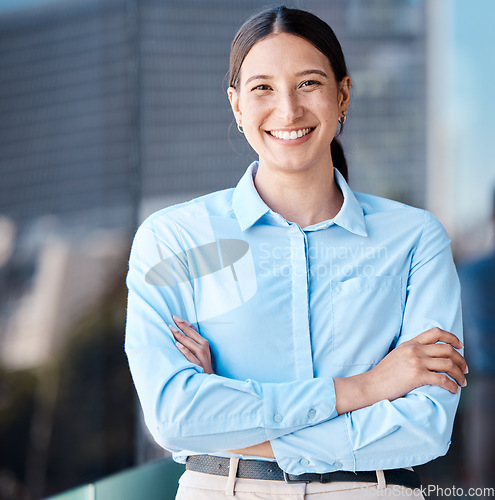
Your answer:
[334,328,468,414]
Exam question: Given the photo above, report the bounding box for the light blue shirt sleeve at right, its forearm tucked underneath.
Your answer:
[271,212,462,474]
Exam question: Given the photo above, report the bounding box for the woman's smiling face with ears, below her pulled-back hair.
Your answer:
[228,33,350,176]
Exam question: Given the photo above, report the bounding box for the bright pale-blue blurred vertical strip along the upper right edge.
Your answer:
[424,0,495,258]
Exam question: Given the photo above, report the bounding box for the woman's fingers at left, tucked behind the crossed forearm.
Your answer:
[169,316,214,374]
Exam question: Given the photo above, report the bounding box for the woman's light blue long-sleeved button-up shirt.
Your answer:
[125,162,462,474]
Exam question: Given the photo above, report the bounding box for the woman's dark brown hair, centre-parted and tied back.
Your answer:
[229,6,348,180]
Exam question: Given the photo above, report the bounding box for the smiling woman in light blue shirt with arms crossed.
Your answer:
[126,7,467,499]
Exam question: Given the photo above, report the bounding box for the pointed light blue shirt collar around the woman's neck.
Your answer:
[232,161,368,236]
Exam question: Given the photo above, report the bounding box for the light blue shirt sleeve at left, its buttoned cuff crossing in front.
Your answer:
[125,214,337,453]
